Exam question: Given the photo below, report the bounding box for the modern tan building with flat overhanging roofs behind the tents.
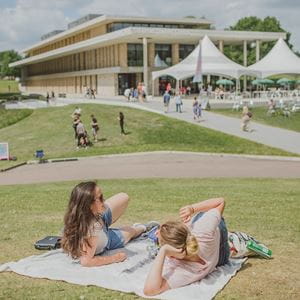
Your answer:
[11,15,286,97]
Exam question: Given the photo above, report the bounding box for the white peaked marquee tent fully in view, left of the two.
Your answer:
[152,35,261,80]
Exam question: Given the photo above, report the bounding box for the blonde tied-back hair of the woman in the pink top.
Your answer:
[159,221,199,256]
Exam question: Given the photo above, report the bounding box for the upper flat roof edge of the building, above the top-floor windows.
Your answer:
[21,15,213,53]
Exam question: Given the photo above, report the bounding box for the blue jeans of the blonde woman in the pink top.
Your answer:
[192,212,230,267]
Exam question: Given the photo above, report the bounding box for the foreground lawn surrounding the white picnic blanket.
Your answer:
[0,178,300,300]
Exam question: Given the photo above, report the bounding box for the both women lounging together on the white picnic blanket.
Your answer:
[62,182,256,296]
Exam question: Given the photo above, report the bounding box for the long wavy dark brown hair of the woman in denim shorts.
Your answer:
[62,181,97,258]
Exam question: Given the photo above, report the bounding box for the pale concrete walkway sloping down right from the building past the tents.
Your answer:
[57,97,300,154]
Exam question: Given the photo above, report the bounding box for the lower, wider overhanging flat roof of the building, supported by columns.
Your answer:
[10,27,286,67]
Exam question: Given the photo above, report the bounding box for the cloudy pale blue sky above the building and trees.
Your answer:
[0,0,300,52]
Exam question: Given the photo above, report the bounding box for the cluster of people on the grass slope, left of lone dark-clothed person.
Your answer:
[72,107,99,149]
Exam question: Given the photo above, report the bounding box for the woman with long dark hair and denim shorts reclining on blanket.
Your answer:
[62,182,157,267]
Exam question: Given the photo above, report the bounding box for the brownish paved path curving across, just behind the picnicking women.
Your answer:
[0,152,300,185]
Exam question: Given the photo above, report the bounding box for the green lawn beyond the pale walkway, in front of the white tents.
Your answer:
[213,107,300,132]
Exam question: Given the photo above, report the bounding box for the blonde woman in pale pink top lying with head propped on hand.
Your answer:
[144,198,229,296]
